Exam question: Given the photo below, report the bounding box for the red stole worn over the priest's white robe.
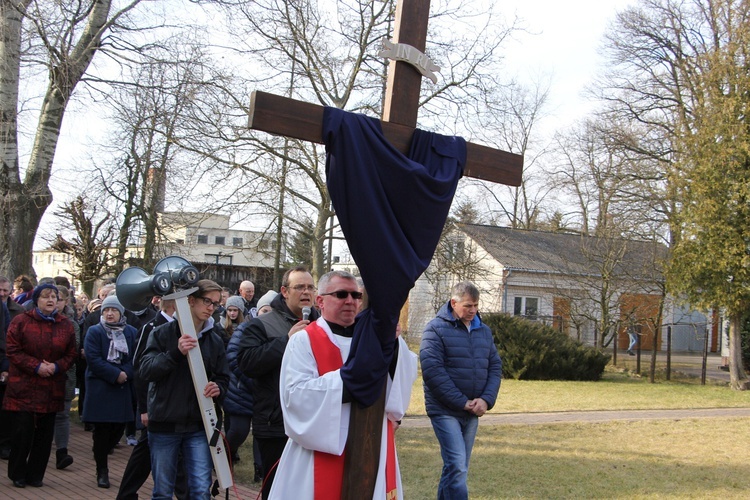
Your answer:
[306,323,397,500]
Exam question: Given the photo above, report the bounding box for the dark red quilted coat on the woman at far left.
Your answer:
[3,309,77,413]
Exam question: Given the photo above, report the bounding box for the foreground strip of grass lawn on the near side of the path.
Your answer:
[397,419,750,500]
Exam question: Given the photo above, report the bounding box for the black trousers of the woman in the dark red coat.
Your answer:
[8,411,57,483]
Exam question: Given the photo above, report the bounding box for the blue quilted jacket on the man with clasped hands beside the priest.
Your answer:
[419,301,502,417]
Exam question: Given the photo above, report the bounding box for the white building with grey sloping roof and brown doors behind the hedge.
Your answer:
[408,224,716,351]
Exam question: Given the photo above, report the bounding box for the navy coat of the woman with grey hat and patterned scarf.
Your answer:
[81,324,138,423]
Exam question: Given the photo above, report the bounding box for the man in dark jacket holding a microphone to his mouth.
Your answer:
[237,266,318,500]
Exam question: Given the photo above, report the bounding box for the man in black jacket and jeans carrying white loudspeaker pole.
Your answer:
[138,280,229,500]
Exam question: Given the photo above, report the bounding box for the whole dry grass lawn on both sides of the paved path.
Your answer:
[235,364,750,500]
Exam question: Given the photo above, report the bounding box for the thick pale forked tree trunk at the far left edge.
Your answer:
[0,0,117,279]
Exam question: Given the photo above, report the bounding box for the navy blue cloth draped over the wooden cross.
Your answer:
[323,108,466,406]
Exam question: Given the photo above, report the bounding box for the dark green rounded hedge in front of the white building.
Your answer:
[482,314,611,380]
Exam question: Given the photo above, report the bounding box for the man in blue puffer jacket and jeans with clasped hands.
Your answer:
[419,281,502,500]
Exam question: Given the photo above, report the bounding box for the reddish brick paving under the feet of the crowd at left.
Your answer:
[0,423,258,500]
